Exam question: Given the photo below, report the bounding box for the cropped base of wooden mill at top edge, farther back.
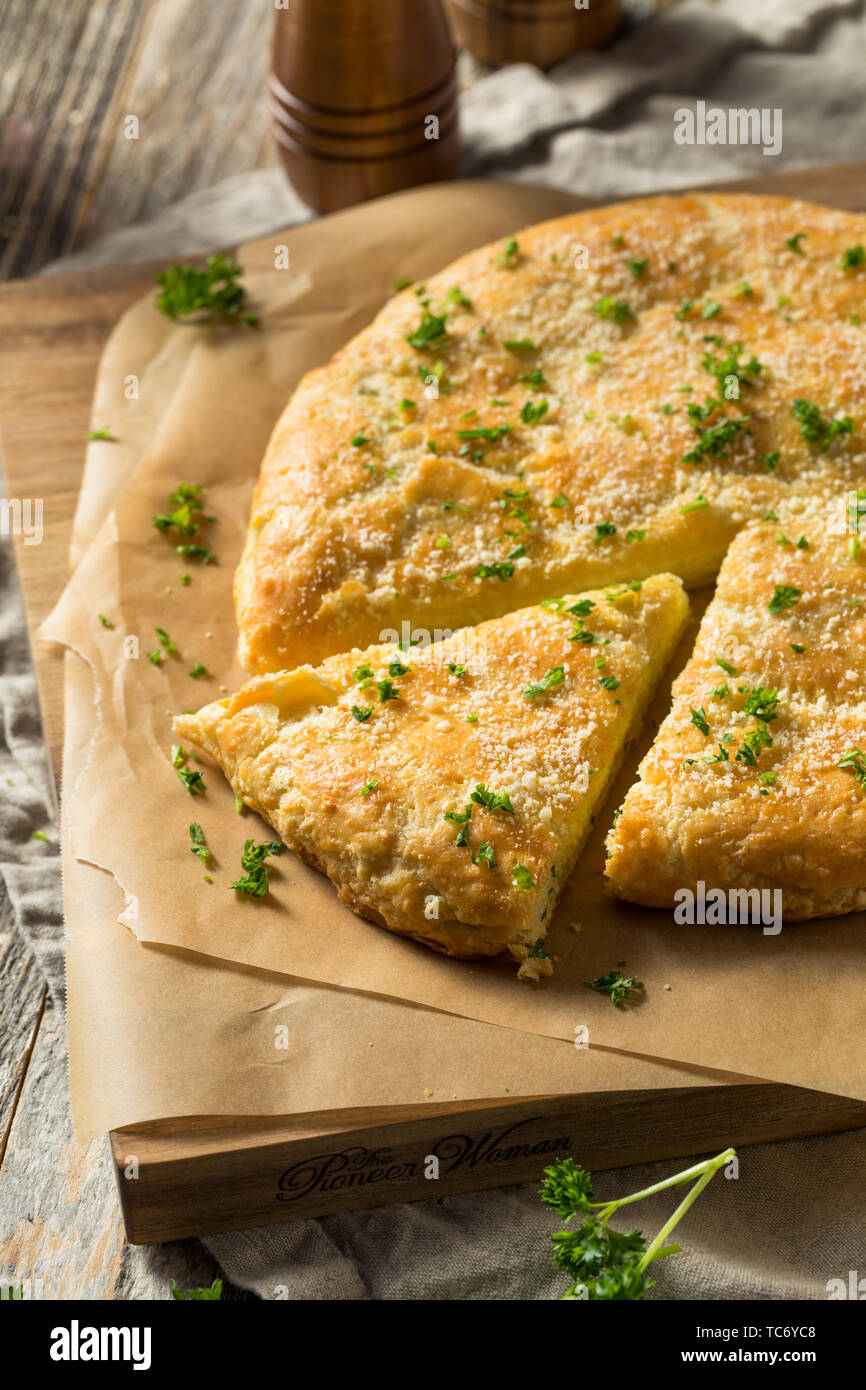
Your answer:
[446,0,621,68]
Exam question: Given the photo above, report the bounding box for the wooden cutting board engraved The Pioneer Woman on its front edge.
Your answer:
[0,164,866,1241]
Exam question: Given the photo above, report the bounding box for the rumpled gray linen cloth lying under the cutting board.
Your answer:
[0,0,866,1300]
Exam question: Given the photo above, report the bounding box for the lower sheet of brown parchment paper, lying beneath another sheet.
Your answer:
[63,182,749,1138]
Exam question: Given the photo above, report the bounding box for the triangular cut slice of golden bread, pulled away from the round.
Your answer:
[175,574,688,973]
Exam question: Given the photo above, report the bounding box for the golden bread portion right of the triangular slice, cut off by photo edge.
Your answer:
[606,493,866,919]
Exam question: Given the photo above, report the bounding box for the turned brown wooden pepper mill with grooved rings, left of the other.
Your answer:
[268,0,459,213]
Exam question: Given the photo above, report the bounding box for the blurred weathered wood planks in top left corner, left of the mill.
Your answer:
[0,0,275,279]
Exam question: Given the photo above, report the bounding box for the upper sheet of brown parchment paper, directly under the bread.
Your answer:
[46,183,866,1123]
